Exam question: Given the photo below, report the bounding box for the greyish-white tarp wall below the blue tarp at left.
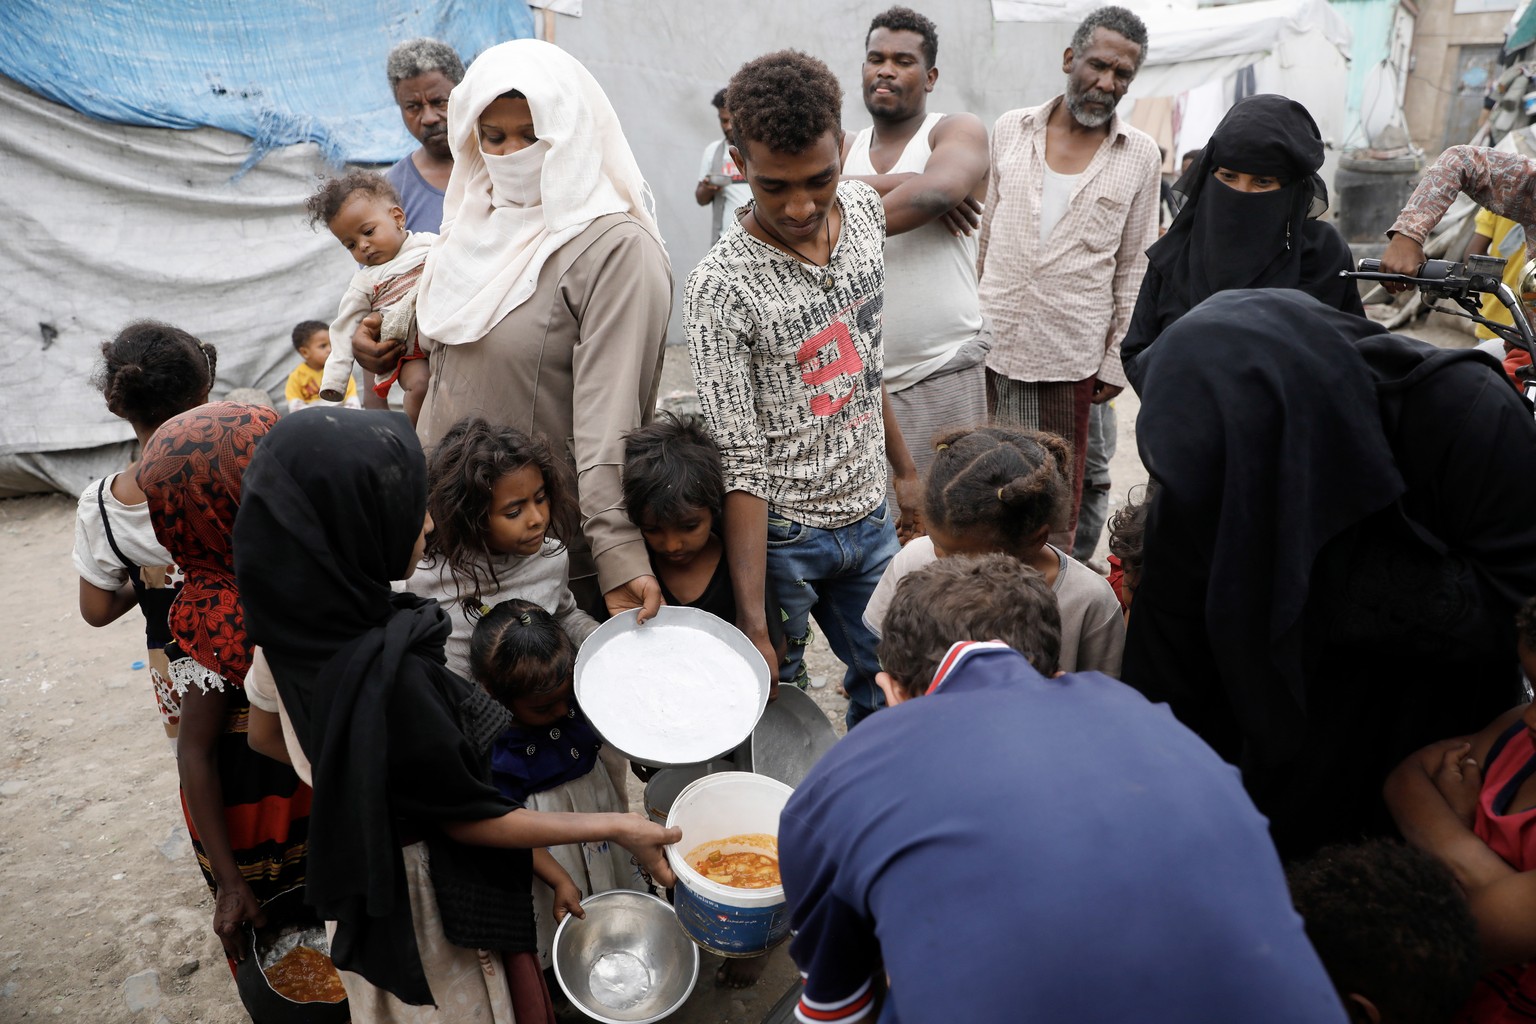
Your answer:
[0,77,353,496]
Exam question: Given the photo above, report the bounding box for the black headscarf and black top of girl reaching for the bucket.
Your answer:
[235,410,527,1006]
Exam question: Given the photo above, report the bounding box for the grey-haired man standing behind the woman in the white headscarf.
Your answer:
[384,38,464,233]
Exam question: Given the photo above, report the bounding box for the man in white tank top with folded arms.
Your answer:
[843,8,991,540]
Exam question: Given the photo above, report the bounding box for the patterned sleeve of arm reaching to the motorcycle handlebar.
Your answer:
[1387,146,1536,258]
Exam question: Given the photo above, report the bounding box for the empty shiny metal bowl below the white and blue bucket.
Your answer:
[551,889,699,1024]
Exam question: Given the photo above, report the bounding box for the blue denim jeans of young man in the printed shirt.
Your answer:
[768,502,900,728]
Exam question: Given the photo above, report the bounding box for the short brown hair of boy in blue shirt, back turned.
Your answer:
[879,553,1061,697]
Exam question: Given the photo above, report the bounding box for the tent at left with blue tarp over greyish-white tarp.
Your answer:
[0,0,531,496]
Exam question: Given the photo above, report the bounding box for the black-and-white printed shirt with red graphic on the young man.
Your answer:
[684,181,886,530]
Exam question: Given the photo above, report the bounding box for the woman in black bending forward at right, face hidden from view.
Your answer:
[1123,289,1536,855]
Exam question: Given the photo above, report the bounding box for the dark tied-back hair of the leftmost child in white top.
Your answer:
[91,319,218,428]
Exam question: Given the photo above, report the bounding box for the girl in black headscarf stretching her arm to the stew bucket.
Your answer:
[235,411,679,1024]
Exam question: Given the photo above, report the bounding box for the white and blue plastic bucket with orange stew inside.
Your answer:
[667,772,794,956]
